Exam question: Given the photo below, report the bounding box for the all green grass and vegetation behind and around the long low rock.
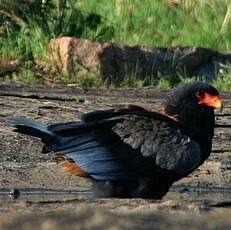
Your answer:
[0,0,231,90]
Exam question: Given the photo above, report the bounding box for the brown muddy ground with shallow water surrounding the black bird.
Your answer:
[0,82,231,229]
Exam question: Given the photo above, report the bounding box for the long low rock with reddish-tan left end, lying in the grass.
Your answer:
[48,37,231,81]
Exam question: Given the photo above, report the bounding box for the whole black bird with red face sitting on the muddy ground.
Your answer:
[8,82,222,199]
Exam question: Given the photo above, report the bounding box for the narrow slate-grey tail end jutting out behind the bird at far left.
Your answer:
[7,117,58,144]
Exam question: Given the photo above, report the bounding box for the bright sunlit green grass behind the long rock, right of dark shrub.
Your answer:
[79,0,231,51]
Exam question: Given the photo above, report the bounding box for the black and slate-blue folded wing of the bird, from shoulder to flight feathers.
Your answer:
[48,106,201,180]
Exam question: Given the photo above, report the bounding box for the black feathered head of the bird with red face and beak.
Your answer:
[164,81,222,122]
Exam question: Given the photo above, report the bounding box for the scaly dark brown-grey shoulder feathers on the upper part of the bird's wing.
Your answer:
[113,115,201,177]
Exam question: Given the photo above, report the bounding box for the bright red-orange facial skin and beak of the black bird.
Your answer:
[198,92,222,108]
